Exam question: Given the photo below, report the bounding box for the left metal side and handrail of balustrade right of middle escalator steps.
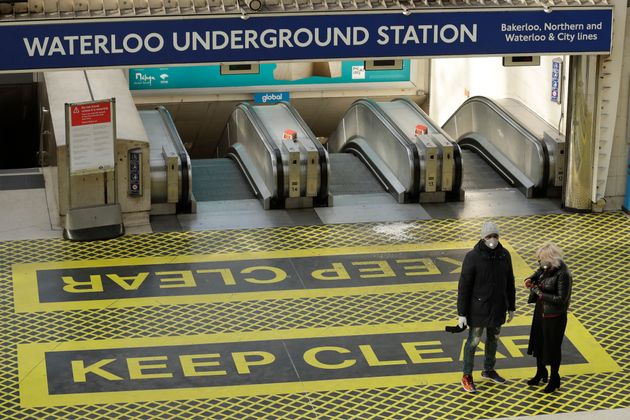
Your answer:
[328,99,419,203]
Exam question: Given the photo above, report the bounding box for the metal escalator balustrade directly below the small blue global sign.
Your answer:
[218,103,329,209]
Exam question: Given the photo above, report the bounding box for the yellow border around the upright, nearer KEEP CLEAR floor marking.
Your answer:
[18,314,620,407]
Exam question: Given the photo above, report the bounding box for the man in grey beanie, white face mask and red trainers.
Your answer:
[457,222,516,392]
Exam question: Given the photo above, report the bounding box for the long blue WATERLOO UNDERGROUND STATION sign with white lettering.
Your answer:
[0,8,612,71]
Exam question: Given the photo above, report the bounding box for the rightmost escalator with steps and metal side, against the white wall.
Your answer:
[442,96,565,198]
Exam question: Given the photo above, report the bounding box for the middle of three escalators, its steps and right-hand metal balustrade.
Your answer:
[328,99,462,204]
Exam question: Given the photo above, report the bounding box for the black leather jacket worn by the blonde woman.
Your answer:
[527,262,573,315]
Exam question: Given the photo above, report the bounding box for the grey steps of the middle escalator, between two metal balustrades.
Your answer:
[329,153,383,195]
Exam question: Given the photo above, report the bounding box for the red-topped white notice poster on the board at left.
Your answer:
[67,99,115,175]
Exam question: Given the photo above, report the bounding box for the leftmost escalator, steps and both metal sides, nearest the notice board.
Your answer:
[140,103,330,214]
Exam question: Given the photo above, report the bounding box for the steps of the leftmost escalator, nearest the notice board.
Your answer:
[192,158,256,201]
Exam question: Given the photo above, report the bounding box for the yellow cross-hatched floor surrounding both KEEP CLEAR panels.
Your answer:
[0,212,630,420]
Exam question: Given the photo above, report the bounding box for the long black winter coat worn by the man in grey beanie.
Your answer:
[457,239,516,327]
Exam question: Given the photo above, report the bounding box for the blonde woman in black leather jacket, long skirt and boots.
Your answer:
[525,243,573,393]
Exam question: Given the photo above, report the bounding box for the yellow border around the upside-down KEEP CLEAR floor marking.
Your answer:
[12,240,532,312]
